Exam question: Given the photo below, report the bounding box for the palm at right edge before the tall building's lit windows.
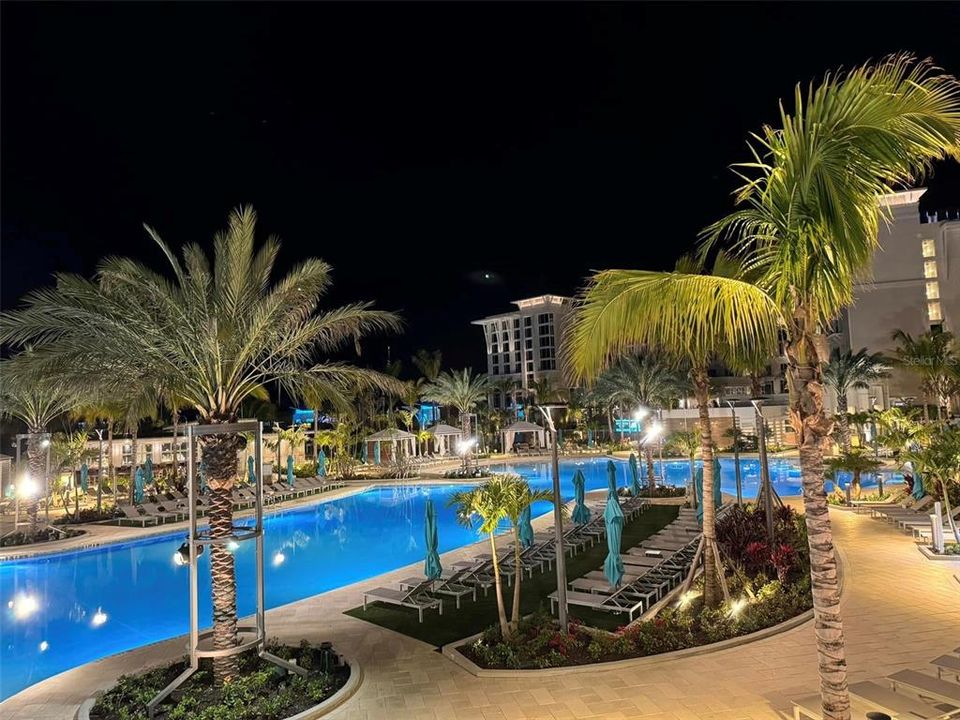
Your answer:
[893,330,960,420]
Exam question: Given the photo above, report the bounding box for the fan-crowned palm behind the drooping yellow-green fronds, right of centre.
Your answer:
[594,353,681,490]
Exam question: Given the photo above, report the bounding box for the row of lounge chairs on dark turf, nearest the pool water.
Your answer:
[363,498,647,623]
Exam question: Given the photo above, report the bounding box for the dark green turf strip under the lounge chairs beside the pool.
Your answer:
[345,505,679,646]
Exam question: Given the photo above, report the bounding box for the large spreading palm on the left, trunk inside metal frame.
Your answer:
[0,208,399,683]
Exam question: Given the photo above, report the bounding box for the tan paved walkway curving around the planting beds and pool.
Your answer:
[0,500,960,720]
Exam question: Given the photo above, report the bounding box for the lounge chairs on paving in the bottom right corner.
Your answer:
[793,647,960,720]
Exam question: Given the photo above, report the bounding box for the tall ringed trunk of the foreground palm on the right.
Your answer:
[786,326,850,720]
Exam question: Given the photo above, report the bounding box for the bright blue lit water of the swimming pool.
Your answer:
[0,459,900,698]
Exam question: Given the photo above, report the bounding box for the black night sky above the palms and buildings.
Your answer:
[0,2,960,376]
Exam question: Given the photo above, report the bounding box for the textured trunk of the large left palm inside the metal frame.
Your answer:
[197,435,246,686]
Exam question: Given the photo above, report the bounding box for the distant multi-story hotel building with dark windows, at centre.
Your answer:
[473,295,573,409]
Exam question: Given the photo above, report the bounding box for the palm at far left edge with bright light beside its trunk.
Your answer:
[0,372,76,536]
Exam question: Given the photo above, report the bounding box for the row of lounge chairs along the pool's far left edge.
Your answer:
[117,478,343,527]
